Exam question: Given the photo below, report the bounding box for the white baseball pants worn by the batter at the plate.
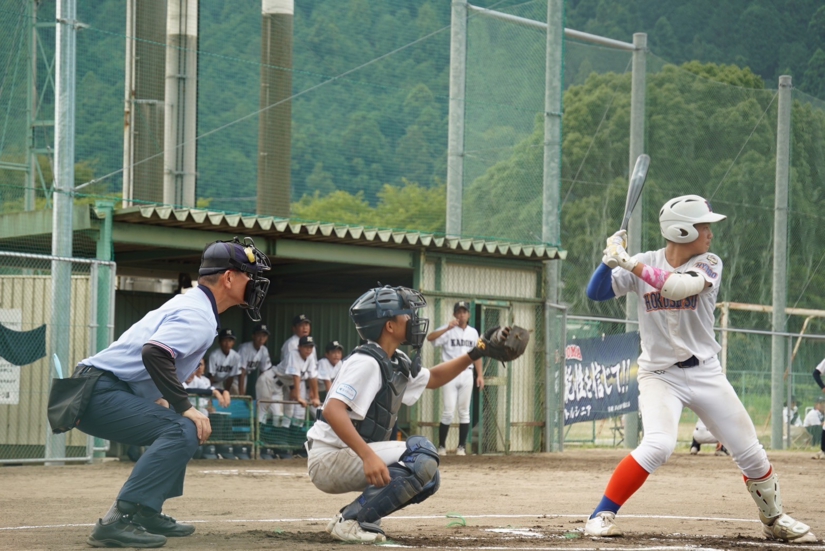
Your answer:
[631,358,771,478]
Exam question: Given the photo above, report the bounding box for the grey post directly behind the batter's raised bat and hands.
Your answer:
[624,33,647,448]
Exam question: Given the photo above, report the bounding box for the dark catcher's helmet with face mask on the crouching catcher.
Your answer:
[349,285,430,347]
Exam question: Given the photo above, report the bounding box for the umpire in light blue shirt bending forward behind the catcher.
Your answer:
[74,237,269,547]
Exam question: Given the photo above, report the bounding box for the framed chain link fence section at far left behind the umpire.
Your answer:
[0,251,114,463]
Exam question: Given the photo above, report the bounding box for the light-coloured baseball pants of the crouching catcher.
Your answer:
[307,440,407,494]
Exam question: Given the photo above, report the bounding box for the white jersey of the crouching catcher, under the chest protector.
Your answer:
[307,354,430,448]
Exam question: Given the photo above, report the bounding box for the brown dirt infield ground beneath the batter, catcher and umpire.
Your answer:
[0,450,825,551]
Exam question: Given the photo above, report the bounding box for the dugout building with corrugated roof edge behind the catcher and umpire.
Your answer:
[0,203,565,460]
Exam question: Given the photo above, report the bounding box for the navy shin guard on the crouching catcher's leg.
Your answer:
[341,436,441,532]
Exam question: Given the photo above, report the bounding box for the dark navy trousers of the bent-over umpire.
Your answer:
[78,372,199,511]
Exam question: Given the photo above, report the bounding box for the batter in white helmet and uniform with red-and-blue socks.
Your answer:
[585,195,816,542]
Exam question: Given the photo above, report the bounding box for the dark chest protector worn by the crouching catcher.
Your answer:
[352,343,411,444]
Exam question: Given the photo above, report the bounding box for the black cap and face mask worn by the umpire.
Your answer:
[198,237,271,321]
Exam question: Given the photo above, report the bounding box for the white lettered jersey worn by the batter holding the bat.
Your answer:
[612,249,722,371]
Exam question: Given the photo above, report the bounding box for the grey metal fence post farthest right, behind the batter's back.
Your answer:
[771,75,792,449]
